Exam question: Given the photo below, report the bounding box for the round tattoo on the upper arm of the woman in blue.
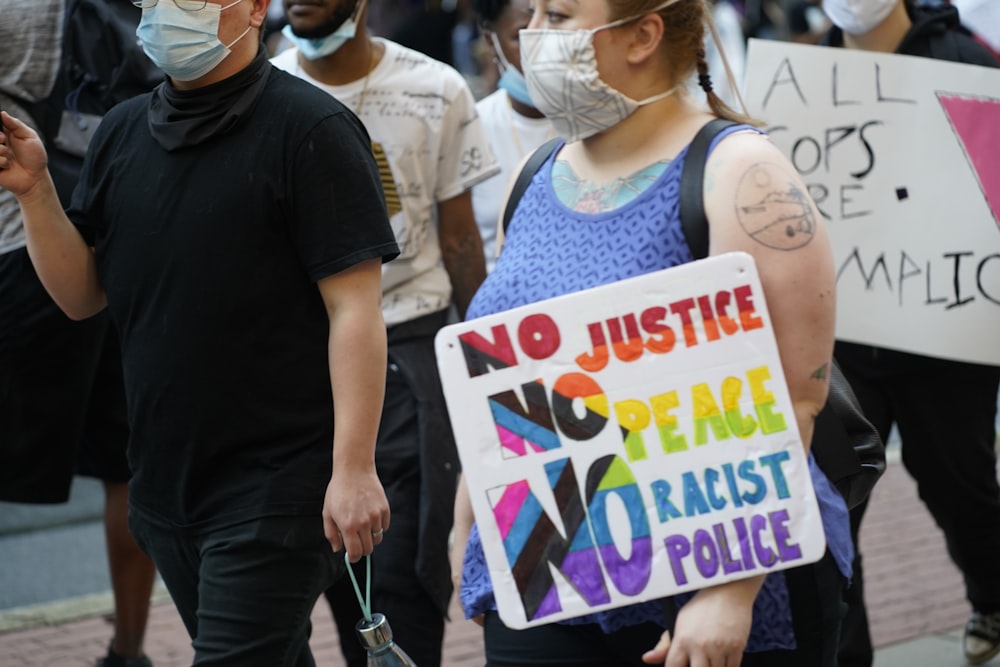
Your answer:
[736,162,816,250]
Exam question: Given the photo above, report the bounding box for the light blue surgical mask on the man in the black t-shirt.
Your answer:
[135,0,251,81]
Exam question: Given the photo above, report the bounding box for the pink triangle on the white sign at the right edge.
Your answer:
[937,93,1000,231]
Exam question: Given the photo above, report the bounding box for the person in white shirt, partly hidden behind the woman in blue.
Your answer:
[472,0,555,273]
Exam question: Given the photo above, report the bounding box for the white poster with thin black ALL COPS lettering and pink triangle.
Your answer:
[744,40,1000,364]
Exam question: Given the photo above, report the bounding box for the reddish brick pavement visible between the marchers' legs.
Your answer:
[0,463,984,667]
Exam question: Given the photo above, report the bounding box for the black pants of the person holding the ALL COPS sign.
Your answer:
[836,343,1000,667]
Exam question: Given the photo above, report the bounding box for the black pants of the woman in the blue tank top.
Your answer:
[484,552,844,667]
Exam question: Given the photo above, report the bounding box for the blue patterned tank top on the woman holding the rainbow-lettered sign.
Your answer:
[460,125,853,652]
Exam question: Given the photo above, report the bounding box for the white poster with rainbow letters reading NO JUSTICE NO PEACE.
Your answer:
[436,253,825,628]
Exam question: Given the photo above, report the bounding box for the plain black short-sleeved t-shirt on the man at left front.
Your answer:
[69,65,398,528]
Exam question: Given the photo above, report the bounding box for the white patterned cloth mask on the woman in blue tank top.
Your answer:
[520,0,680,143]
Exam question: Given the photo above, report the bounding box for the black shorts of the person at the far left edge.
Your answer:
[0,248,129,503]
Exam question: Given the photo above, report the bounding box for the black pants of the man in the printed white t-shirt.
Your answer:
[326,364,444,667]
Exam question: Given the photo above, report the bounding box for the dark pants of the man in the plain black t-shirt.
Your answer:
[129,512,344,667]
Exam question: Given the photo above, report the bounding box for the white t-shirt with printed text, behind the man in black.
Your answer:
[271,39,499,326]
